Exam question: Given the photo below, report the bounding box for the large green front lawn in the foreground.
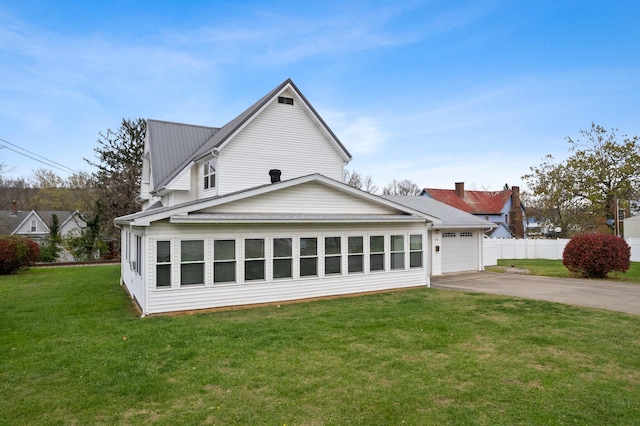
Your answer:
[0,266,640,425]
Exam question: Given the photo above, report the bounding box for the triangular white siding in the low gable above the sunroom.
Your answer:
[209,182,399,214]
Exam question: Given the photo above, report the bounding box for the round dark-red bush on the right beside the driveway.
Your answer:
[562,234,631,278]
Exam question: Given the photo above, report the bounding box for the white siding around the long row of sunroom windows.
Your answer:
[141,223,429,314]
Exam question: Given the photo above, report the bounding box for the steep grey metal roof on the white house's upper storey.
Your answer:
[147,78,352,191]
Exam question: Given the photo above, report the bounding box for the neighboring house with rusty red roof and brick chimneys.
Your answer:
[420,182,526,238]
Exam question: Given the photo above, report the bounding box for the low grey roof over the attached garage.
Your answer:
[382,195,496,229]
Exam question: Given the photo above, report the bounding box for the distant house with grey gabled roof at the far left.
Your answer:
[0,201,87,260]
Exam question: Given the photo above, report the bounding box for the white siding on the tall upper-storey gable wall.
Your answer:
[218,93,344,195]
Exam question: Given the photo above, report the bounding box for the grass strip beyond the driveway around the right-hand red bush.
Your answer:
[485,259,640,283]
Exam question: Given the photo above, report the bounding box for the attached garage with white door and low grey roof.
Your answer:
[383,195,496,275]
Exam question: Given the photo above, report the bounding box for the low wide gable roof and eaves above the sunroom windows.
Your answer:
[114,173,440,226]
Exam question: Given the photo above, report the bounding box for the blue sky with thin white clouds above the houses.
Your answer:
[0,0,640,190]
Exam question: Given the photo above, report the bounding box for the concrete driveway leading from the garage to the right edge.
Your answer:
[431,272,640,315]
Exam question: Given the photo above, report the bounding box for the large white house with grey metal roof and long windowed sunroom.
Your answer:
[115,80,493,315]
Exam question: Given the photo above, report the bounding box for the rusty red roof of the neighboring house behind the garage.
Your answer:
[421,188,511,214]
